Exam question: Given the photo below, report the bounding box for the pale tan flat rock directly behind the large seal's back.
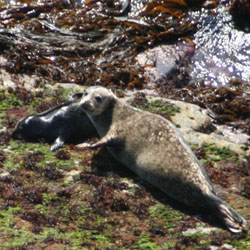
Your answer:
[125,91,250,155]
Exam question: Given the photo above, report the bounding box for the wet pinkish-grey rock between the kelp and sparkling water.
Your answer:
[136,43,194,87]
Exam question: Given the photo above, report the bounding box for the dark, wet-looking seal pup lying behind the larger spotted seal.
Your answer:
[12,93,97,151]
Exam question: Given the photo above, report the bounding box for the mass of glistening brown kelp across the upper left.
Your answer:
[0,0,207,87]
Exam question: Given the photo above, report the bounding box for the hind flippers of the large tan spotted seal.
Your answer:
[208,195,247,233]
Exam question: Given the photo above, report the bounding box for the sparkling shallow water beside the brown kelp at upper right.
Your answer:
[191,3,250,87]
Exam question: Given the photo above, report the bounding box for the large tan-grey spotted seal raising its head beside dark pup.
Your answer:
[79,86,246,233]
